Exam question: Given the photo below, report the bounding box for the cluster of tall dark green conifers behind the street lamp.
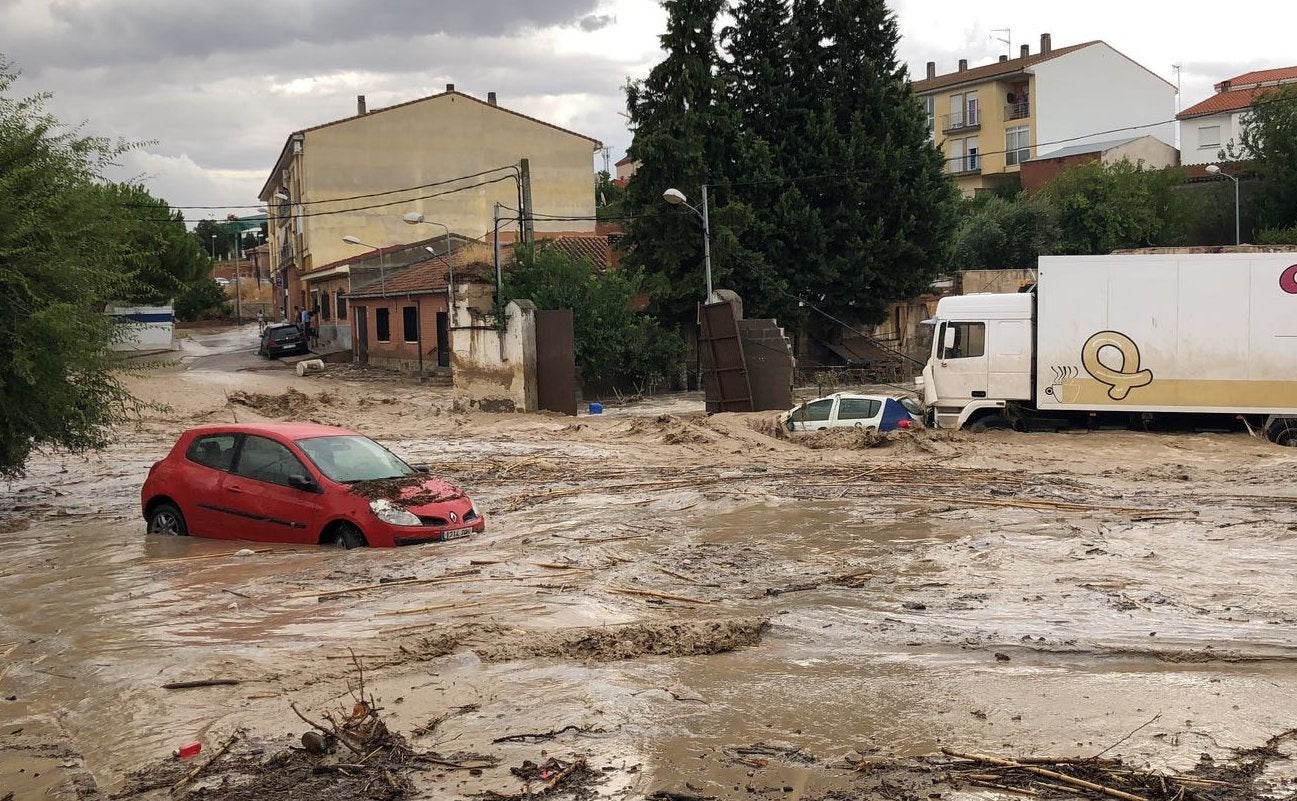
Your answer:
[625,0,956,324]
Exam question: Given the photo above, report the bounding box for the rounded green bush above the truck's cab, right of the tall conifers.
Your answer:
[951,193,1058,270]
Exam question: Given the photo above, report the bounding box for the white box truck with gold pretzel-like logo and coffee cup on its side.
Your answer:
[922,253,1297,445]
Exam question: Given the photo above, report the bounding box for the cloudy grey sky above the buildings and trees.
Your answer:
[0,0,1297,220]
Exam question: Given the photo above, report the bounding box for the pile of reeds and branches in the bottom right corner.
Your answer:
[942,730,1297,801]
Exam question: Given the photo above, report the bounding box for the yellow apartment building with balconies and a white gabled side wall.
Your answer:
[910,34,1175,196]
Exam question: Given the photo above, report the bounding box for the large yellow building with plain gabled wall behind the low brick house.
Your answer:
[259,84,602,336]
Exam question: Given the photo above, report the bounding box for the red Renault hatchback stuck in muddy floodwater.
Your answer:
[140,423,486,548]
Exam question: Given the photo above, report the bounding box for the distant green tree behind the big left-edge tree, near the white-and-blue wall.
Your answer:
[100,184,211,303]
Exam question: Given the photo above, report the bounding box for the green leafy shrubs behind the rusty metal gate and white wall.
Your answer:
[501,241,684,388]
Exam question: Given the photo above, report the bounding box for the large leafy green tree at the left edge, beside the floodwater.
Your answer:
[0,58,137,477]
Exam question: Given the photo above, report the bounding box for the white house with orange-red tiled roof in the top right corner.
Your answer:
[1175,66,1297,165]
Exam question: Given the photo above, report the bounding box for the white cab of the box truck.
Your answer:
[923,293,1035,429]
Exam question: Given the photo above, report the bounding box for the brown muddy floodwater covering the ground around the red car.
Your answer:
[0,321,1297,800]
